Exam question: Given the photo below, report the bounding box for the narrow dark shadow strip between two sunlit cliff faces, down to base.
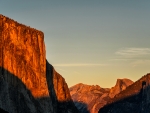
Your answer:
[46,60,78,113]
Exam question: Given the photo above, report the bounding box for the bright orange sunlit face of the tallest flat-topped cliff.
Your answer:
[0,15,49,98]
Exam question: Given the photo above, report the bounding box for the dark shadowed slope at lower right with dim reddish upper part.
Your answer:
[98,77,150,113]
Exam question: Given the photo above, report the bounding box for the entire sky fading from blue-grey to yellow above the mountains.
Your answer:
[0,0,150,87]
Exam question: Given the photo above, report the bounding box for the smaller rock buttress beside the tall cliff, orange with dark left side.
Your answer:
[46,62,78,113]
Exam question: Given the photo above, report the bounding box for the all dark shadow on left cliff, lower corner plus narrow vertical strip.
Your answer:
[0,62,78,113]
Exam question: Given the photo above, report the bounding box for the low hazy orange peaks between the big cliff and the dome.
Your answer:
[70,83,110,113]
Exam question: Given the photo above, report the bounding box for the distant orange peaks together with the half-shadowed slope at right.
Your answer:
[70,73,150,113]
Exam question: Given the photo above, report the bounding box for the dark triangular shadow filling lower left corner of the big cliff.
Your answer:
[0,67,47,113]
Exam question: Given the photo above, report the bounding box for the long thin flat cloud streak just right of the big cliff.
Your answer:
[54,63,108,67]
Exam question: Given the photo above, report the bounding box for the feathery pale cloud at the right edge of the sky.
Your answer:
[115,48,150,58]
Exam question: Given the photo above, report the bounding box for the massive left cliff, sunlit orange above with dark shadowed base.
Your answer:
[0,15,78,113]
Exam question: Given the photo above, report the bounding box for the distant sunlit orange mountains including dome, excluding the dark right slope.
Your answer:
[70,79,133,113]
